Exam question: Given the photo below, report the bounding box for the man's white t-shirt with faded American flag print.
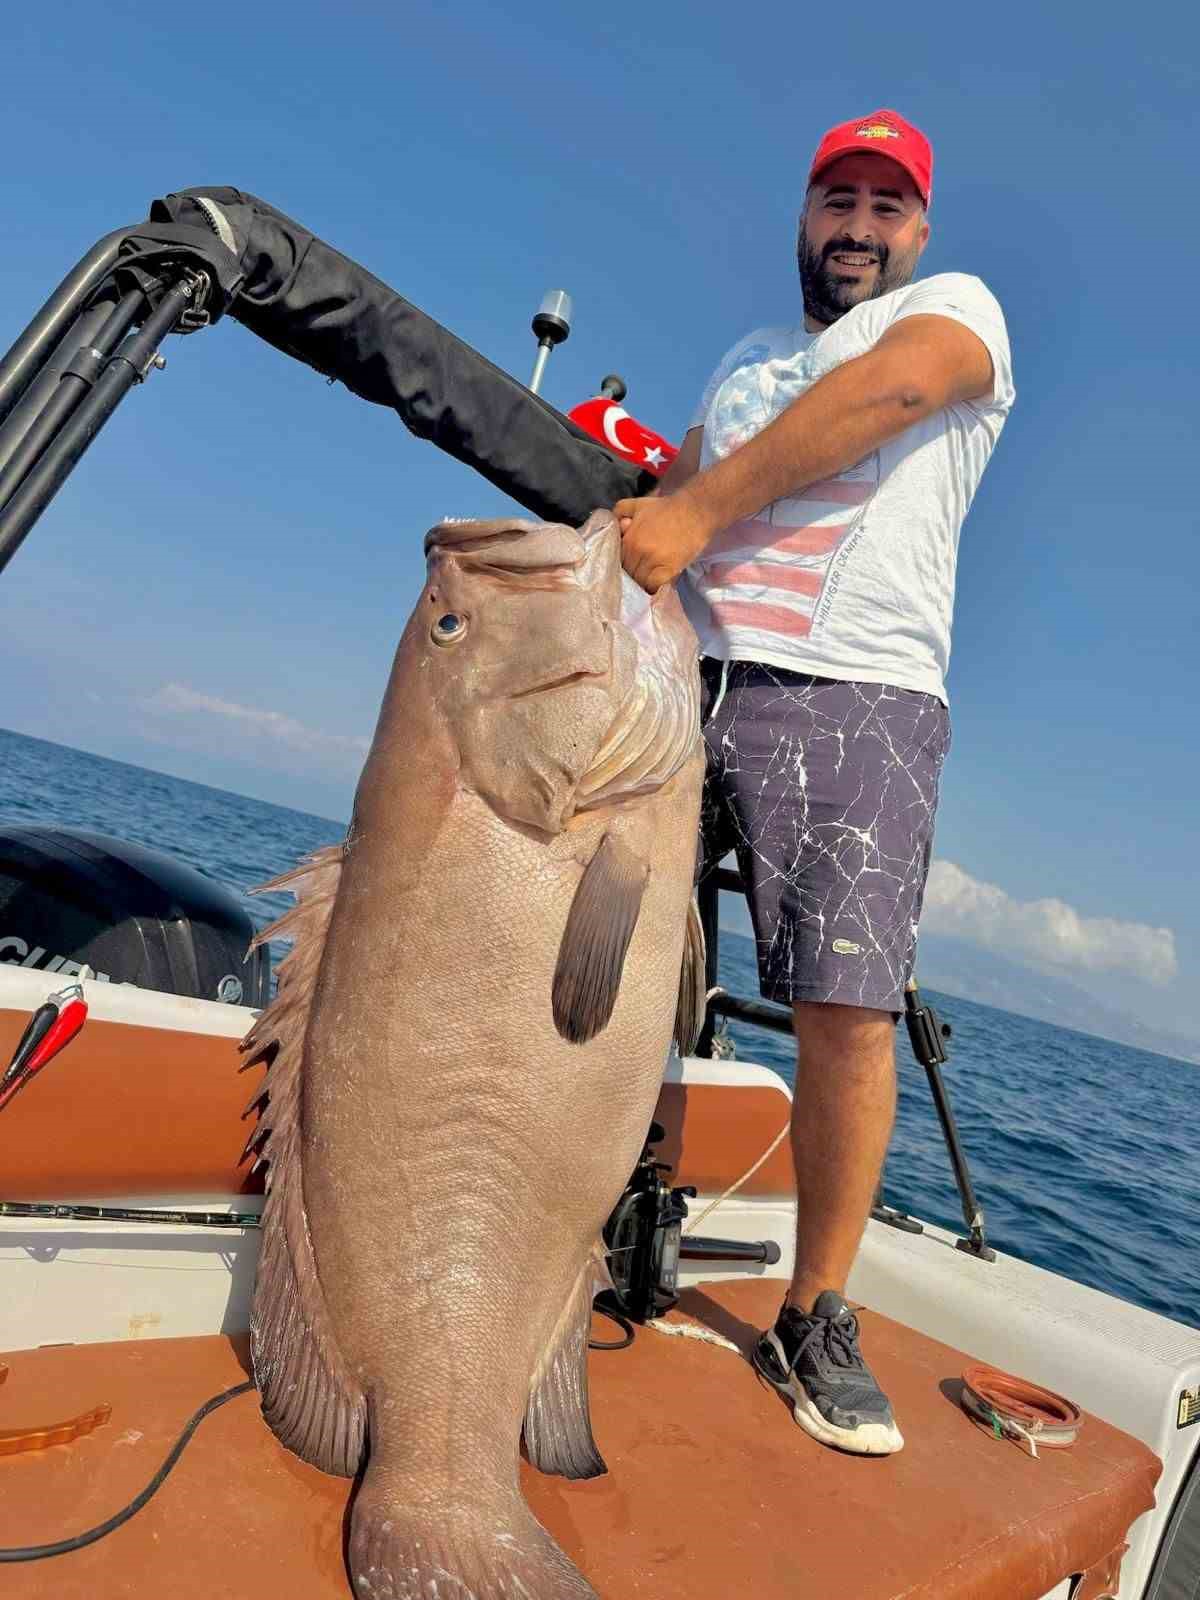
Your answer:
[678,272,1016,701]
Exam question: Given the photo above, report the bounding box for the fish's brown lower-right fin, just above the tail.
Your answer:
[525,1242,611,1478]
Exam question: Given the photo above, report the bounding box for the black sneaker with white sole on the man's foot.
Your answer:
[754,1290,904,1456]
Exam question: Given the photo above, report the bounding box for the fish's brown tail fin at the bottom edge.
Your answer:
[349,1467,598,1600]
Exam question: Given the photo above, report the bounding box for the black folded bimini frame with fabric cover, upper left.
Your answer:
[0,189,656,570]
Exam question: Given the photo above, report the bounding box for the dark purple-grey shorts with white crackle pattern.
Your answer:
[698,658,950,1013]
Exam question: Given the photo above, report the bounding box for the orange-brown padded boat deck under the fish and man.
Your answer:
[0,1280,1160,1600]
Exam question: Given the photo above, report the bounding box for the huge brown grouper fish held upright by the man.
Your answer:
[245,512,704,1600]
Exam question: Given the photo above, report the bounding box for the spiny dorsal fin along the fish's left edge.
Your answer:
[242,845,366,1477]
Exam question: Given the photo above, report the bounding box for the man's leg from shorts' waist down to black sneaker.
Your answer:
[720,664,949,1456]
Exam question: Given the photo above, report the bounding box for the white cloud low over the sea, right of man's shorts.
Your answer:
[922,861,1178,987]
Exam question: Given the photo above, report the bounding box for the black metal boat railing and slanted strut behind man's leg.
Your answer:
[696,867,995,1261]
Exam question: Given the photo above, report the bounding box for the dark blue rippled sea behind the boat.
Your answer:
[0,730,1200,1326]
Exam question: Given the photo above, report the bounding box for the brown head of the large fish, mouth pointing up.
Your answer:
[412,512,698,832]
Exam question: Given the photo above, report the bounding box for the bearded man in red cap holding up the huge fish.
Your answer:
[616,110,1014,1454]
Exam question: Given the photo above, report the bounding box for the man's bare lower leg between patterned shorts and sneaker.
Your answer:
[787,1002,896,1314]
